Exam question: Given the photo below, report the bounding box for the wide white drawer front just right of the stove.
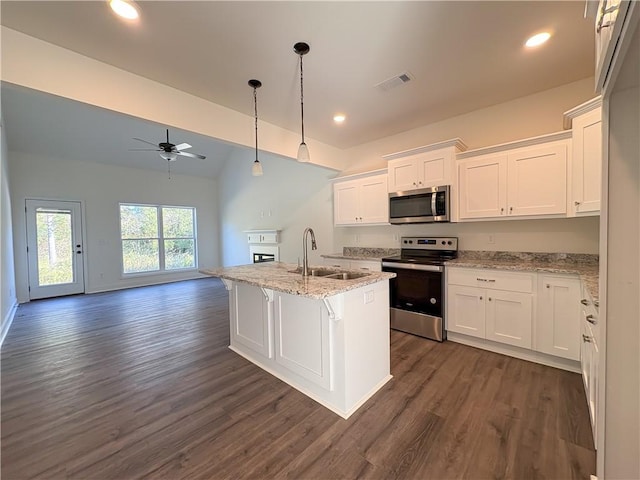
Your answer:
[447,267,535,293]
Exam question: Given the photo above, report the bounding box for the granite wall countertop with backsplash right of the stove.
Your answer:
[445,251,599,302]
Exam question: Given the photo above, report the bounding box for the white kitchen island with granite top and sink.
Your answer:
[202,262,395,418]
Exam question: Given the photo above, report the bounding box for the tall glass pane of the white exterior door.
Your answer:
[36,208,74,285]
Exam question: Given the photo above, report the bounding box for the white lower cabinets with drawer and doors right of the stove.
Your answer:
[445,267,591,371]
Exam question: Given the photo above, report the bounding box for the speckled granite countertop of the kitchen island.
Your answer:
[200,262,396,299]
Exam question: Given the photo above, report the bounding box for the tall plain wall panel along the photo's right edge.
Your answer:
[598,18,640,479]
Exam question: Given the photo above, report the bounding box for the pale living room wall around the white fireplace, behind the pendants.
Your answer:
[218,152,336,266]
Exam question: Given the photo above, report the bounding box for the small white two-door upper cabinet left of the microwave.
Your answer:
[333,172,389,225]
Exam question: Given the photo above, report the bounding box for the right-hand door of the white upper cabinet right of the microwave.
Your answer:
[507,145,567,215]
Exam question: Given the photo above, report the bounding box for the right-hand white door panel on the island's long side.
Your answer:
[274,293,332,390]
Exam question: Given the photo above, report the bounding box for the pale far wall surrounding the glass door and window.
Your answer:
[9,152,220,302]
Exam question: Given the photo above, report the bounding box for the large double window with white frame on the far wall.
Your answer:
[120,204,196,274]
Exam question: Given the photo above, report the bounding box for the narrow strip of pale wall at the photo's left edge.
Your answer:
[0,111,17,344]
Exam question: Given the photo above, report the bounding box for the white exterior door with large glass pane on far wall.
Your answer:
[26,200,84,300]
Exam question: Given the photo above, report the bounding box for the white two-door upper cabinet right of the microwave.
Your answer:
[458,132,571,220]
